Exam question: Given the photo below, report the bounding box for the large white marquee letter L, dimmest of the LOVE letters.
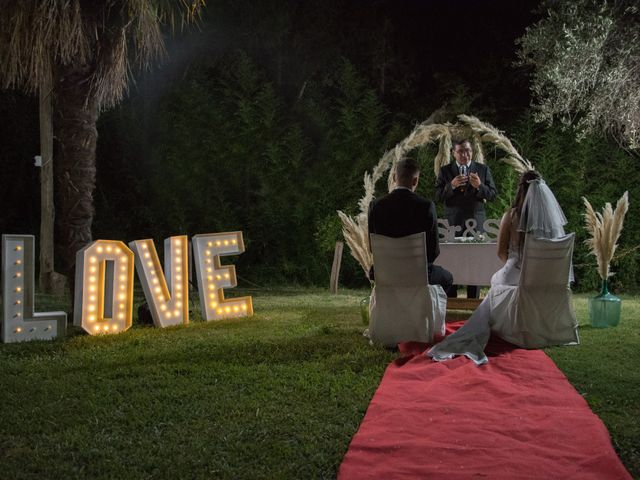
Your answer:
[2,235,67,343]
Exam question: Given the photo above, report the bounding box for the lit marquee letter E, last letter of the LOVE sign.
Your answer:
[191,232,253,320]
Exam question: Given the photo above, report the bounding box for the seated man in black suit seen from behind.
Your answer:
[369,158,453,294]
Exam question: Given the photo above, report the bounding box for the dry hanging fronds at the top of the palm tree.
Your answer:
[0,0,204,107]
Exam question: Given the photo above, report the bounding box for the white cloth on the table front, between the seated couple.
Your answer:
[434,243,504,285]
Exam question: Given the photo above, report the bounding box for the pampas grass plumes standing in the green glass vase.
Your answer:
[582,192,629,280]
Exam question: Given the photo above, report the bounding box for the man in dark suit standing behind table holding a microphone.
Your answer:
[436,139,498,298]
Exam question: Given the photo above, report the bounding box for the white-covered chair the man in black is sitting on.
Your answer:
[368,232,447,347]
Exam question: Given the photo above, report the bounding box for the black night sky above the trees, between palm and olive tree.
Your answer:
[154,0,539,118]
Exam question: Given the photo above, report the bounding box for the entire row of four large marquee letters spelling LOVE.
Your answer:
[2,232,253,342]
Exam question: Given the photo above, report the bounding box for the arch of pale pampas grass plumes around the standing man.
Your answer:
[338,115,533,273]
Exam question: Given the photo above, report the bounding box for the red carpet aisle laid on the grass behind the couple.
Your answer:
[338,323,631,480]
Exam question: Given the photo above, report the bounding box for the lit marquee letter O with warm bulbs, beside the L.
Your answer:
[73,240,134,335]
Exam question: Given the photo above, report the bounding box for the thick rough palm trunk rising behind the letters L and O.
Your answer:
[56,66,98,282]
